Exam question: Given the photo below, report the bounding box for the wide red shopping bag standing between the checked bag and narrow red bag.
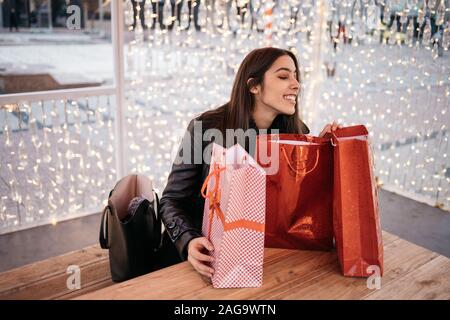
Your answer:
[256,134,333,250]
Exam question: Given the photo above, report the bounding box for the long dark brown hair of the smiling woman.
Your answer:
[198,47,309,133]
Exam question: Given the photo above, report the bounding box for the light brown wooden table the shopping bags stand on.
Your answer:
[77,232,450,300]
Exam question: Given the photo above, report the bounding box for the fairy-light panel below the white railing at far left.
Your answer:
[0,96,116,233]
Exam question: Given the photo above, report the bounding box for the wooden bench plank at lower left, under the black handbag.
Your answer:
[0,245,113,300]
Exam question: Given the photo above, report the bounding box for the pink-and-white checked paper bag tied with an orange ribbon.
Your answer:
[202,144,266,288]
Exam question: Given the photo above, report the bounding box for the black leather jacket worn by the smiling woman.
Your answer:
[160,117,309,260]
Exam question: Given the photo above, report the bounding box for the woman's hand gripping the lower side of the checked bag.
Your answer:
[188,237,214,278]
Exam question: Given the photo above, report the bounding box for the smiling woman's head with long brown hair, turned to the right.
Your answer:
[198,47,309,133]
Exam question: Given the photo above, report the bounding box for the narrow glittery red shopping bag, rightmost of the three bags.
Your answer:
[330,125,383,277]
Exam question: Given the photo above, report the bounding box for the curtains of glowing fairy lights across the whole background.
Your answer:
[0,0,450,232]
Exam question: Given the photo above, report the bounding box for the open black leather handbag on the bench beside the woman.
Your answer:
[99,174,161,282]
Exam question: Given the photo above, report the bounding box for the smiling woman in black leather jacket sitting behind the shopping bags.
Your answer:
[160,47,340,278]
